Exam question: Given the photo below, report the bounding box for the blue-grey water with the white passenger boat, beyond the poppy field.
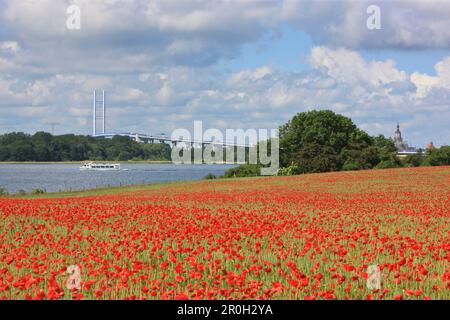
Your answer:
[0,163,233,193]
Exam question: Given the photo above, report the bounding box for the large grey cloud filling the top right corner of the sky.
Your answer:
[282,0,450,49]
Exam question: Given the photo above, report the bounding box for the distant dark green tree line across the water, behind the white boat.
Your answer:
[0,132,171,162]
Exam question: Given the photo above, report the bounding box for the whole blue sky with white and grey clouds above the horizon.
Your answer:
[0,0,450,146]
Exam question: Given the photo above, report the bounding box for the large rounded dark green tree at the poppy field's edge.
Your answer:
[280,110,386,172]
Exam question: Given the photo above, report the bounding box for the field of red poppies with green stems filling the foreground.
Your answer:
[0,166,450,300]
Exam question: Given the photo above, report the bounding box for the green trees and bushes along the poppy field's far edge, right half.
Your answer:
[224,110,450,177]
